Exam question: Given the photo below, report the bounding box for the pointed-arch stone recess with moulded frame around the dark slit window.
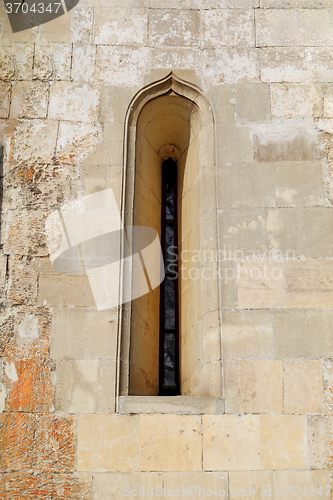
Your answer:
[117,72,222,397]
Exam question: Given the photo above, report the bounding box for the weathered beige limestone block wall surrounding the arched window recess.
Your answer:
[0,0,333,500]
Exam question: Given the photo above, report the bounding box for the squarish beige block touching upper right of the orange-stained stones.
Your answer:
[50,307,87,359]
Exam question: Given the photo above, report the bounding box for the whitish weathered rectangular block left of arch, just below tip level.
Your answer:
[49,82,100,122]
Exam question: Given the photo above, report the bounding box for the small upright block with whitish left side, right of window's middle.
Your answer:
[266,208,303,261]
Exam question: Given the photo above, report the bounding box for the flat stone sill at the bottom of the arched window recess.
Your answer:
[118,396,224,415]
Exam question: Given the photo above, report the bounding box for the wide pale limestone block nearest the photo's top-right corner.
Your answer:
[256,9,333,47]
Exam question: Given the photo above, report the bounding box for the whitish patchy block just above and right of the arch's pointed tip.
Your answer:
[197,48,260,87]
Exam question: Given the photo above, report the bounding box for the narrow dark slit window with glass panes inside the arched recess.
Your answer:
[159,158,180,396]
